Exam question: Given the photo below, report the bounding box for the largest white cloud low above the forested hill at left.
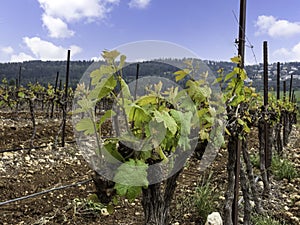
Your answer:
[23,37,81,60]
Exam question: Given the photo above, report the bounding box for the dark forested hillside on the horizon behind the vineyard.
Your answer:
[0,59,300,91]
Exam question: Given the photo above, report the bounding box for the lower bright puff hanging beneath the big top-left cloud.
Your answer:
[42,14,75,38]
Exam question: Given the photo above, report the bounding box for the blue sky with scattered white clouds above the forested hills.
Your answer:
[0,0,300,64]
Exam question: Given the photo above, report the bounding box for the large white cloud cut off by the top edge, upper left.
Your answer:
[38,0,120,38]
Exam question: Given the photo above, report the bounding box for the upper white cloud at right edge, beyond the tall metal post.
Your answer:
[255,15,300,37]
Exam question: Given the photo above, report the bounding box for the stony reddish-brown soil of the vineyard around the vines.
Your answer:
[0,112,300,225]
